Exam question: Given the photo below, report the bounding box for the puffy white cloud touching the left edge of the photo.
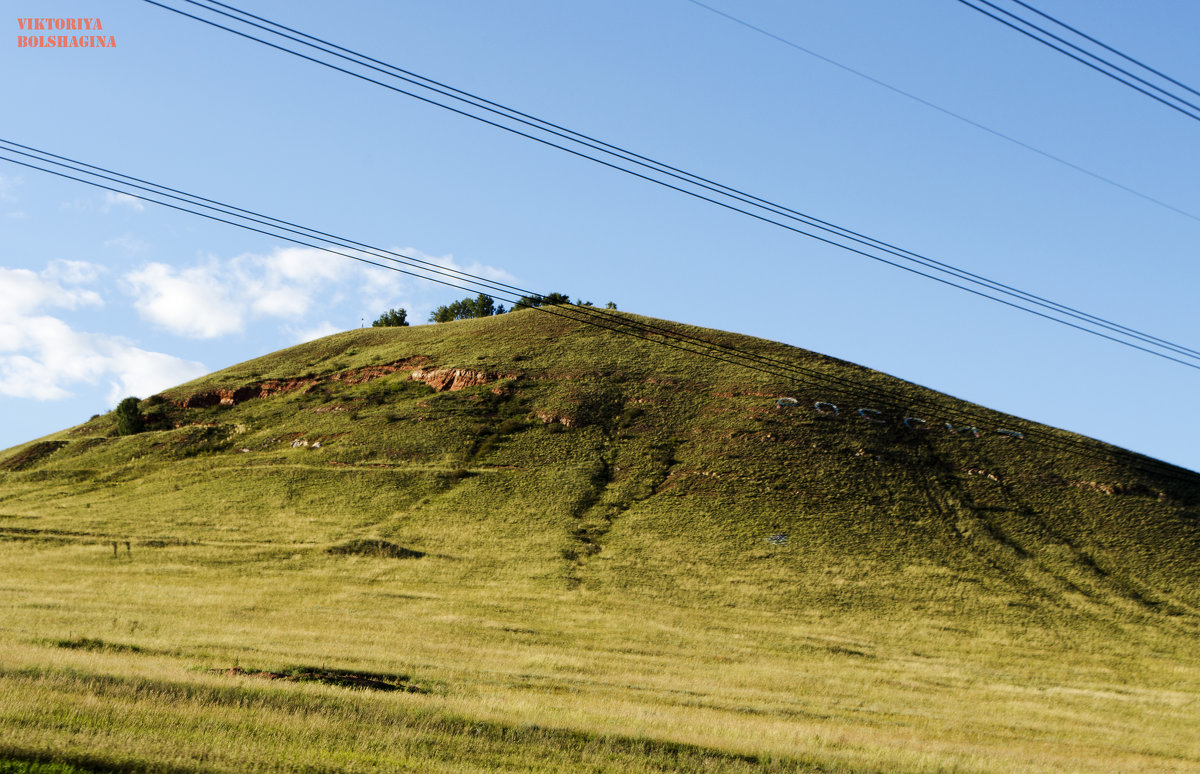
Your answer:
[0,260,205,400]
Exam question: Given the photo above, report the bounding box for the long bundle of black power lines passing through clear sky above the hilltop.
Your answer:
[144,0,1200,370]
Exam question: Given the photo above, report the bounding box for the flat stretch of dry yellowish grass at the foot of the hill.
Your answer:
[0,542,1200,772]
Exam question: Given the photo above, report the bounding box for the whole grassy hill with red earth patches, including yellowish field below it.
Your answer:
[0,311,1200,772]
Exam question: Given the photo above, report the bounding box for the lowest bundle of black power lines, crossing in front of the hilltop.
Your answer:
[0,139,1192,480]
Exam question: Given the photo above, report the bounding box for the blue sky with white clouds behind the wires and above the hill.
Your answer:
[0,0,1200,469]
